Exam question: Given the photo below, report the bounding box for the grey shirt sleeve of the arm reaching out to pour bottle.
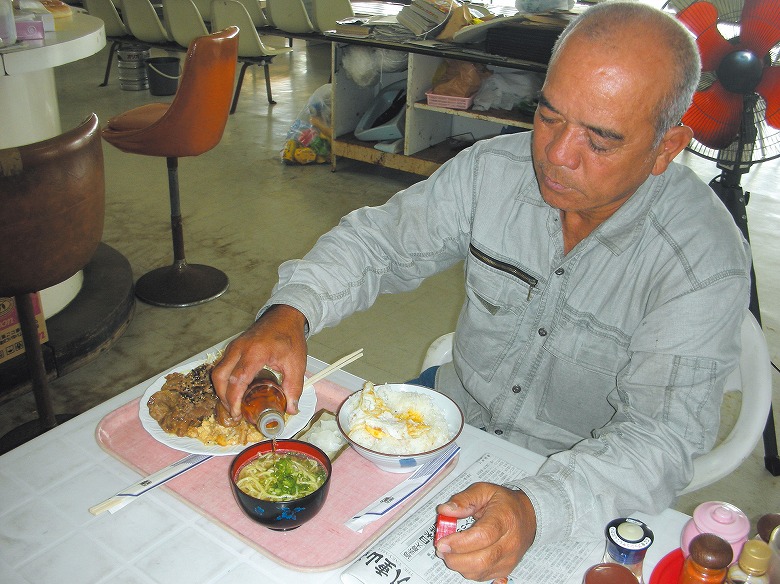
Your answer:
[258,144,484,335]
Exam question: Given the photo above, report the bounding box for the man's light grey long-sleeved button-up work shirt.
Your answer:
[266,132,750,542]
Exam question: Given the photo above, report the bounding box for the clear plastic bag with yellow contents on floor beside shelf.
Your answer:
[281,83,331,164]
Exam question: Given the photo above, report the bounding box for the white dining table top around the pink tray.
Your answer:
[0,341,688,584]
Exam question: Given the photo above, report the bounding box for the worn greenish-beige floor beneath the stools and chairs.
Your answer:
[0,36,780,520]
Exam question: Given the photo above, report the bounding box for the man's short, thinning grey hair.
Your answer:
[550,1,701,146]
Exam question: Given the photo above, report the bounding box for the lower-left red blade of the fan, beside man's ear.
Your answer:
[682,81,742,150]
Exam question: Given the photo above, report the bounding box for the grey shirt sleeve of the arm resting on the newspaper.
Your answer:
[507,272,749,543]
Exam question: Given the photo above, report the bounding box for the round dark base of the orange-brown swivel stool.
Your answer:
[135,261,229,308]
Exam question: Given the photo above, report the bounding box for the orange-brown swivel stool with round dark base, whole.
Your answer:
[103,26,238,307]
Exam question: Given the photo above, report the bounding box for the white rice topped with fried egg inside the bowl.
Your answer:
[347,383,450,454]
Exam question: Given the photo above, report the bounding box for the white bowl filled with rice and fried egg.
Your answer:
[336,383,463,473]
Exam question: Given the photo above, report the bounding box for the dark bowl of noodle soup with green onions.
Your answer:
[230,439,331,531]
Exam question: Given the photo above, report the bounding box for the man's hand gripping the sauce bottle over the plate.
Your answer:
[211,304,306,420]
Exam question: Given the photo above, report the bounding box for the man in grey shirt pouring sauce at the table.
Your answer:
[213,2,750,580]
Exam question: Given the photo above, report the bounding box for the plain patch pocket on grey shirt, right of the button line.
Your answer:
[537,315,629,438]
